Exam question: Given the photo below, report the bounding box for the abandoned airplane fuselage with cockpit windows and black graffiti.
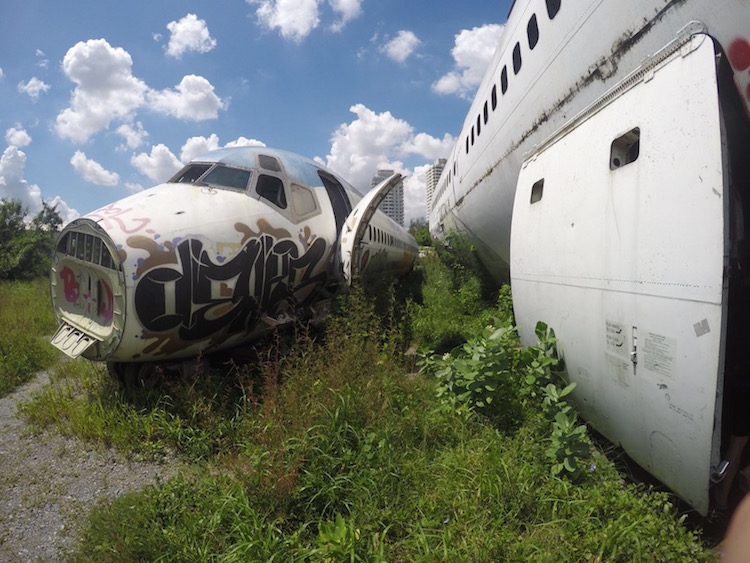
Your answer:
[51,147,417,374]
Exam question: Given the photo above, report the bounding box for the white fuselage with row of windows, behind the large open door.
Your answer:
[429,0,750,278]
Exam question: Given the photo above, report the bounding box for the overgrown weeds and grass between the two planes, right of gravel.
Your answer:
[14,231,713,561]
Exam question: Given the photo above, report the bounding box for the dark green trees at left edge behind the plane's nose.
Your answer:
[0,199,62,280]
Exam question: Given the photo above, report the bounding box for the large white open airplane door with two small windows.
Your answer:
[511,35,729,514]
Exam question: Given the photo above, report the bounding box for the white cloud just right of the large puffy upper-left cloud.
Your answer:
[147,74,225,121]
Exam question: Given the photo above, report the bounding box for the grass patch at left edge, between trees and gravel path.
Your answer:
[0,279,58,397]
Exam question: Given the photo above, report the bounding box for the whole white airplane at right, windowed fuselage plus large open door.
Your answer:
[430,0,750,514]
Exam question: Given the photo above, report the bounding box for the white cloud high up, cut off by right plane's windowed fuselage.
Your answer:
[432,24,505,98]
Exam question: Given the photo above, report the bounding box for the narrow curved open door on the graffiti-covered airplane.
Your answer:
[339,174,402,285]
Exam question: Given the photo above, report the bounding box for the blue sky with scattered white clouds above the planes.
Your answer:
[0,0,510,224]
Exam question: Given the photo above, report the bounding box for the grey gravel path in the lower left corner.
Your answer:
[0,372,177,563]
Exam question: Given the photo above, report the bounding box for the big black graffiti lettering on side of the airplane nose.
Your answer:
[129,229,330,353]
